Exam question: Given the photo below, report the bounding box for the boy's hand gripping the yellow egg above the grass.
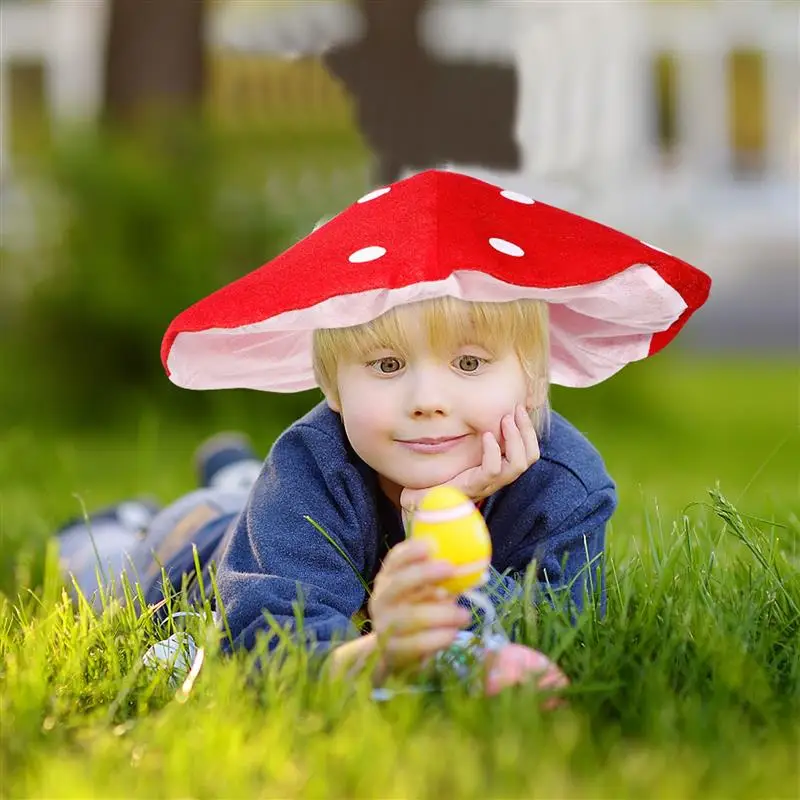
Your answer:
[368,539,472,674]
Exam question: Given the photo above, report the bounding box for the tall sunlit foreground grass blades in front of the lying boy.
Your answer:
[0,490,800,797]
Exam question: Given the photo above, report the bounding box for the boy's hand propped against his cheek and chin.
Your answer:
[400,405,540,513]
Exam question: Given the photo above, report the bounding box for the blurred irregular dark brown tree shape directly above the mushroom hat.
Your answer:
[324,0,520,183]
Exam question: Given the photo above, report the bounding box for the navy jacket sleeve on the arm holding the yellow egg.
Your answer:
[218,425,373,652]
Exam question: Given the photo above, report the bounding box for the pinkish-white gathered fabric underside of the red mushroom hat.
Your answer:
[167,264,687,392]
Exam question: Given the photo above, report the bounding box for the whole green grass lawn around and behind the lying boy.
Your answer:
[0,359,800,800]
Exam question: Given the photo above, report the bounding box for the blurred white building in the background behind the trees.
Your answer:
[0,0,800,346]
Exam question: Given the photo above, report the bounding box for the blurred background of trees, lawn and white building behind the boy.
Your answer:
[0,0,800,588]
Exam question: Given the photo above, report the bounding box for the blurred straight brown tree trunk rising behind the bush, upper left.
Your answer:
[104,0,206,124]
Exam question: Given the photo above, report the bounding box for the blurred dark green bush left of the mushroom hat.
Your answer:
[0,126,334,432]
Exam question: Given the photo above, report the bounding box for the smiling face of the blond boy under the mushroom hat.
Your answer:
[328,306,535,502]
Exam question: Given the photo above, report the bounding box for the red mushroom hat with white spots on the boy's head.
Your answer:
[161,170,711,392]
